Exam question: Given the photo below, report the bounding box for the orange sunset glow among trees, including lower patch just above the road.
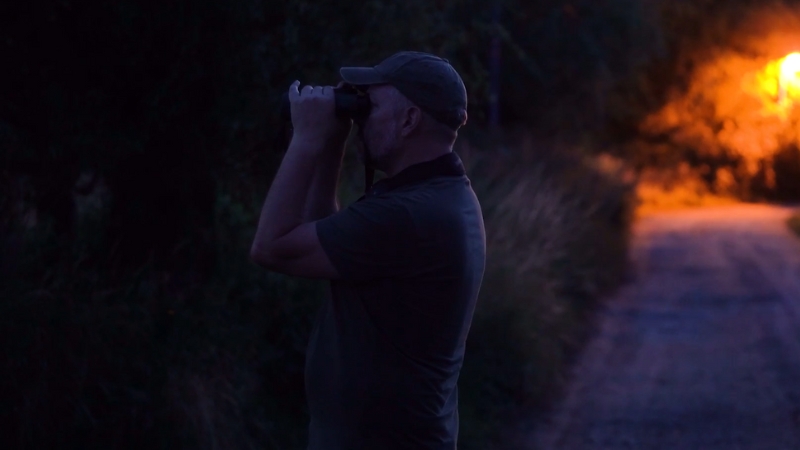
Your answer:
[638,44,800,209]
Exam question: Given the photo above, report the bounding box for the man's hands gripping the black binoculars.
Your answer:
[289,81,353,151]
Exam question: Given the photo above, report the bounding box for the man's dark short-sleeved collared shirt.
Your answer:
[306,153,486,450]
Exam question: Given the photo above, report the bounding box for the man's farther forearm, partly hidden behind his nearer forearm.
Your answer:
[303,151,343,222]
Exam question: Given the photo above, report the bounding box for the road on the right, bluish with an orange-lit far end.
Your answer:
[521,205,800,450]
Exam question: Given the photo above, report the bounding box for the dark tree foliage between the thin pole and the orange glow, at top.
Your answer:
[500,0,664,140]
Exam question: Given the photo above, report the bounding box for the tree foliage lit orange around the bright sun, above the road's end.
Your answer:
[606,0,800,202]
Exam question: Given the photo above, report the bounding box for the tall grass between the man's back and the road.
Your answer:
[460,140,635,449]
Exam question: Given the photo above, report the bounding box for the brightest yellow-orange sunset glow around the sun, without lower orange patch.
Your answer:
[642,48,800,167]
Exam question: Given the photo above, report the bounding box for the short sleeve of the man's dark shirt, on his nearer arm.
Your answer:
[316,197,416,281]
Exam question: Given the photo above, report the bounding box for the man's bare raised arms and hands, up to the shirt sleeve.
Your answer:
[250,82,350,278]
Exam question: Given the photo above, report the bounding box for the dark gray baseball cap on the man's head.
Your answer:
[339,52,467,130]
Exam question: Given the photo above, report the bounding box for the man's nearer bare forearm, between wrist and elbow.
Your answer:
[253,139,320,251]
